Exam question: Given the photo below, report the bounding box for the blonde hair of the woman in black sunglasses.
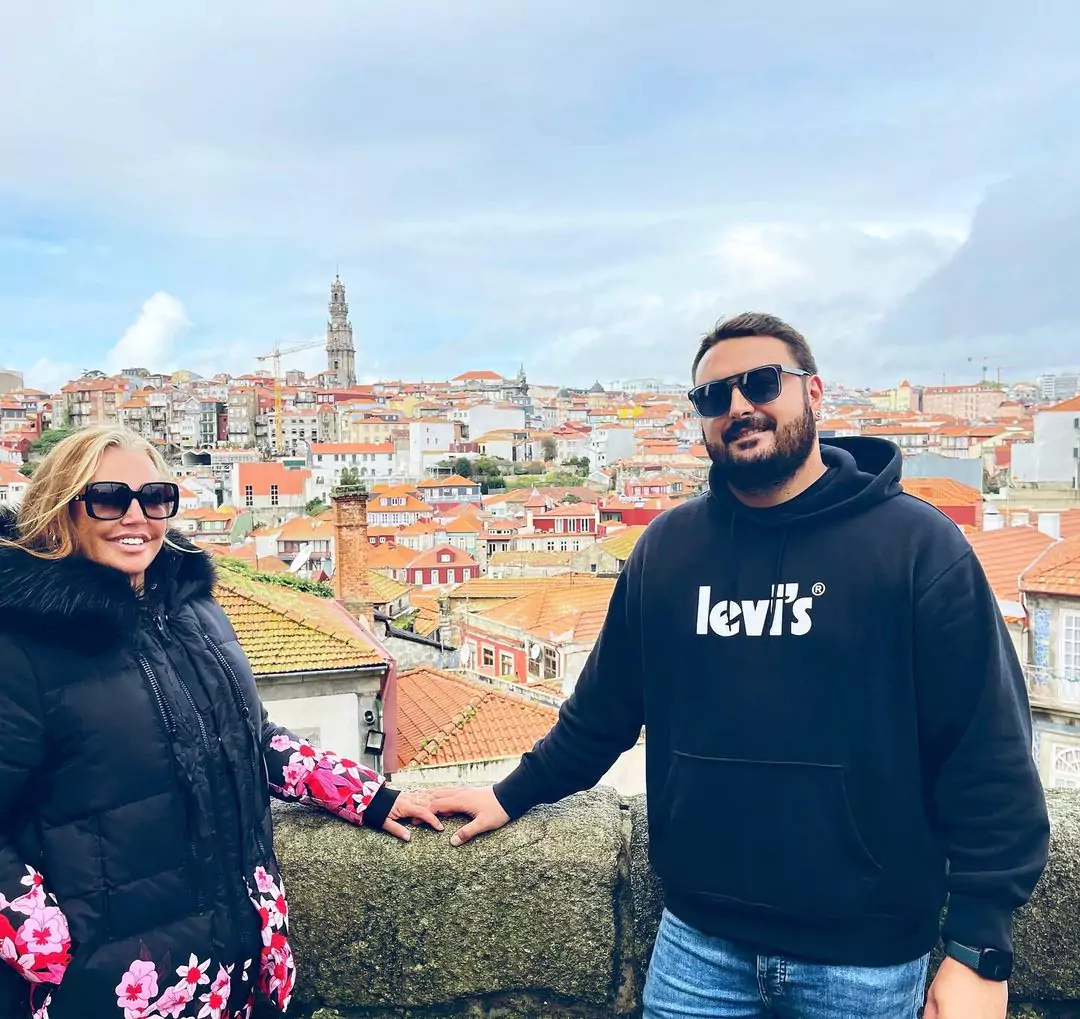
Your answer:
[0,424,173,559]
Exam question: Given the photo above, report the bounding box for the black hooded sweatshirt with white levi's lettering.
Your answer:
[496,438,1049,965]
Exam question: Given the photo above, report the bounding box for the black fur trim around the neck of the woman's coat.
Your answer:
[0,508,214,651]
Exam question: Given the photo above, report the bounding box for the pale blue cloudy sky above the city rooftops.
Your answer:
[0,0,1080,390]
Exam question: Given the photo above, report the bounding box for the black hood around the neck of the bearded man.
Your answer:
[708,436,903,528]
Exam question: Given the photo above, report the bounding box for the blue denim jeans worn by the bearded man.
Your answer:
[644,910,929,1019]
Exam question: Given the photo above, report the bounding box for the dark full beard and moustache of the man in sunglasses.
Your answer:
[705,400,818,495]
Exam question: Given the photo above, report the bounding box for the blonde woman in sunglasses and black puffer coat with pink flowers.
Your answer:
[0,426,442,1019]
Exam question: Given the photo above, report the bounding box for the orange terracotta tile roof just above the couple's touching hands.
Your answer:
[397,666,558,769]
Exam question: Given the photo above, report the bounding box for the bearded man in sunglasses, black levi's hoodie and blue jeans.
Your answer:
[432,314,1049,1019]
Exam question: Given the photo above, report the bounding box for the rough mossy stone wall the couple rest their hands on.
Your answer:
[263,788,1080,1019]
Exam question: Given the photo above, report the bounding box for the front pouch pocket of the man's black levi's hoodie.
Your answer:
[658,751,881,920]
